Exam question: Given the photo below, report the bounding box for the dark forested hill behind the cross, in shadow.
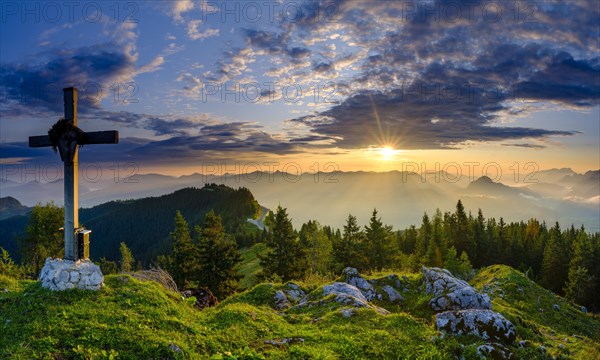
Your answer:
[0,184,260,265]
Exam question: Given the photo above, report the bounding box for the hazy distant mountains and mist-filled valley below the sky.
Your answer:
[0,168,600,231]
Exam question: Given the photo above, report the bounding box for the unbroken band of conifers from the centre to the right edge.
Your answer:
[261,200,600,311]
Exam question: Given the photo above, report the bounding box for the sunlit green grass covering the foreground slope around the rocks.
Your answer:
[0,266,600,359]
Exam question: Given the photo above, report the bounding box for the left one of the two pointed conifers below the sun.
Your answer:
[332,214,366,271]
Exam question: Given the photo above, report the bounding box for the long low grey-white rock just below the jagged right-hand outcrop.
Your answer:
[435,309,517,344]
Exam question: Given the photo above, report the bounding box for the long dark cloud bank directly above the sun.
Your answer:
[294,86,575,149]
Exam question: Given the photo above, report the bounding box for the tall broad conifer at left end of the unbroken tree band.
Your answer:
[259,206,308,281]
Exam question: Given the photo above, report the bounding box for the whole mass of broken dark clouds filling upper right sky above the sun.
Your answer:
[282,1,600,149]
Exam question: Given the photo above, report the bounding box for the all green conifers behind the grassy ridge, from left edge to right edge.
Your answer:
[0,200,600,311]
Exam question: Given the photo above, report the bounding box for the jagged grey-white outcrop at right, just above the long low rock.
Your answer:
[423,267,492,311]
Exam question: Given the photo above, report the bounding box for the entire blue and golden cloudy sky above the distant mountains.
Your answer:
[0,0,600,175]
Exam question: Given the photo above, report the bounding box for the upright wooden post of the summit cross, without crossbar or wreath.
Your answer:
[63,87,79,260]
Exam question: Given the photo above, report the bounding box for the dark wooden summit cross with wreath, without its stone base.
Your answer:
[29,87,119,261]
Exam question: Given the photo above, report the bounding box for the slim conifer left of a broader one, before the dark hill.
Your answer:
[171,210,199,288]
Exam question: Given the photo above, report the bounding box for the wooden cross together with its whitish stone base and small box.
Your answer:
[29,87,119,290]
